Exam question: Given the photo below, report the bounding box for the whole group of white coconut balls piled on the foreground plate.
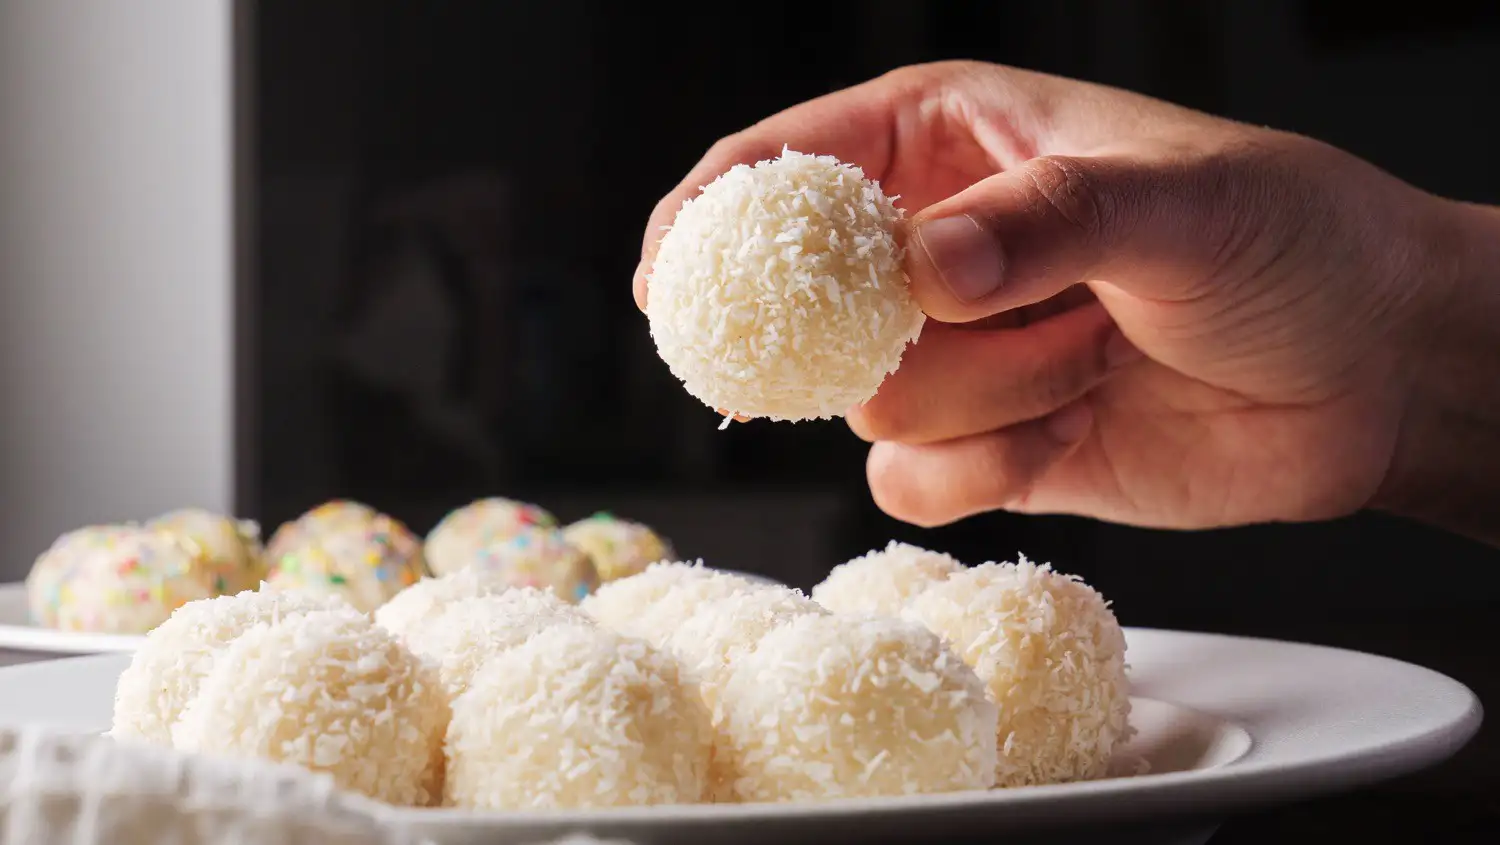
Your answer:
[111,543,1130,809]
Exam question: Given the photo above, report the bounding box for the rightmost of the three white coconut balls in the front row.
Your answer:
[716,614,998,801]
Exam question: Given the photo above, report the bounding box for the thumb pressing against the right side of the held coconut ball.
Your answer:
[908,156,1242,323]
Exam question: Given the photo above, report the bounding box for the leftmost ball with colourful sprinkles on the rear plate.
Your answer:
[27,525,215,633]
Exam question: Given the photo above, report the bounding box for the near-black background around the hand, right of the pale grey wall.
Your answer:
[249,0,1500,843]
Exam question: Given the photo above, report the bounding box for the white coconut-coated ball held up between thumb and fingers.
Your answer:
[647,150,924,420]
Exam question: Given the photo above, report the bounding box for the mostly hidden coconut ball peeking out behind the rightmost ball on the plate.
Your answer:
[813,540,963,615]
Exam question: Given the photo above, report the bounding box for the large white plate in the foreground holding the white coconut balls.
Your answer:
[0,629,1481,845]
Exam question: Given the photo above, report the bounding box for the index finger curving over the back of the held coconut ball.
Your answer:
[635,77,899,311]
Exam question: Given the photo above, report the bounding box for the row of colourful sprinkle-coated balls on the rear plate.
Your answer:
[27,497,672,633]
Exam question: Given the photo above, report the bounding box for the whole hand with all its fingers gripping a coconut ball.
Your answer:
[636,63,1488,528]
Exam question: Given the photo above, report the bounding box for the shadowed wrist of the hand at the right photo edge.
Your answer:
[1373,201,1500,545]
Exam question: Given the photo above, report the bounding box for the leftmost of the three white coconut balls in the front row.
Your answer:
[173,611,449,806]
